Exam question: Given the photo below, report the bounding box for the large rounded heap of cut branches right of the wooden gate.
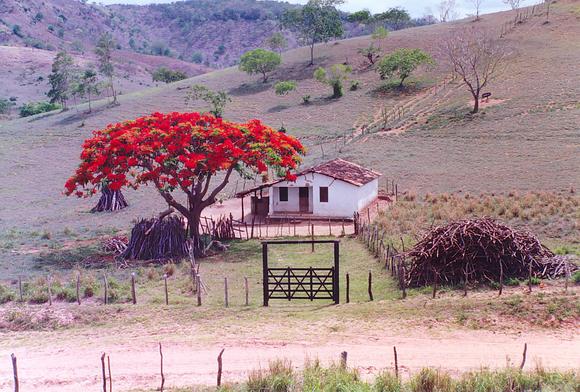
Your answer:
[405,218,577,287]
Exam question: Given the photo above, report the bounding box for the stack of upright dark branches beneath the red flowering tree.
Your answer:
[121,210,190,260]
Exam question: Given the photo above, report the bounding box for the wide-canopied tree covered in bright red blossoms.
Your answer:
[65,113,304,255]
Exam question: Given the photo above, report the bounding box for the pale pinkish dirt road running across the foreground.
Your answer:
[0,330,580,392]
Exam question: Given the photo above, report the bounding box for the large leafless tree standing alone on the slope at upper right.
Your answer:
[441,28,508,114]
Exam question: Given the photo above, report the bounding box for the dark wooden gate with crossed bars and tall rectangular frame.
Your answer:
[262,240,340,306]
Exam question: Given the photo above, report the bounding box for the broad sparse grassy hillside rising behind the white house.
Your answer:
[0,1,580,276]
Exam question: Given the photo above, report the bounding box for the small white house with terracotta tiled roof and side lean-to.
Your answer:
[238,159,381,219]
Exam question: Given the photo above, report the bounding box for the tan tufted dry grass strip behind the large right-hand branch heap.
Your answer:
[378,191,580,254]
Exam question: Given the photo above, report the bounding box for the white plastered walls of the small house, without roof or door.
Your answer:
[269,173,378,218]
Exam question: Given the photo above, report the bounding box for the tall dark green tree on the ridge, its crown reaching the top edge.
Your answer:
[281,0,344,65]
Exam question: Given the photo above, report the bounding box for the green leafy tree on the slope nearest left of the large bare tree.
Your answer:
[377,48,435,88]
